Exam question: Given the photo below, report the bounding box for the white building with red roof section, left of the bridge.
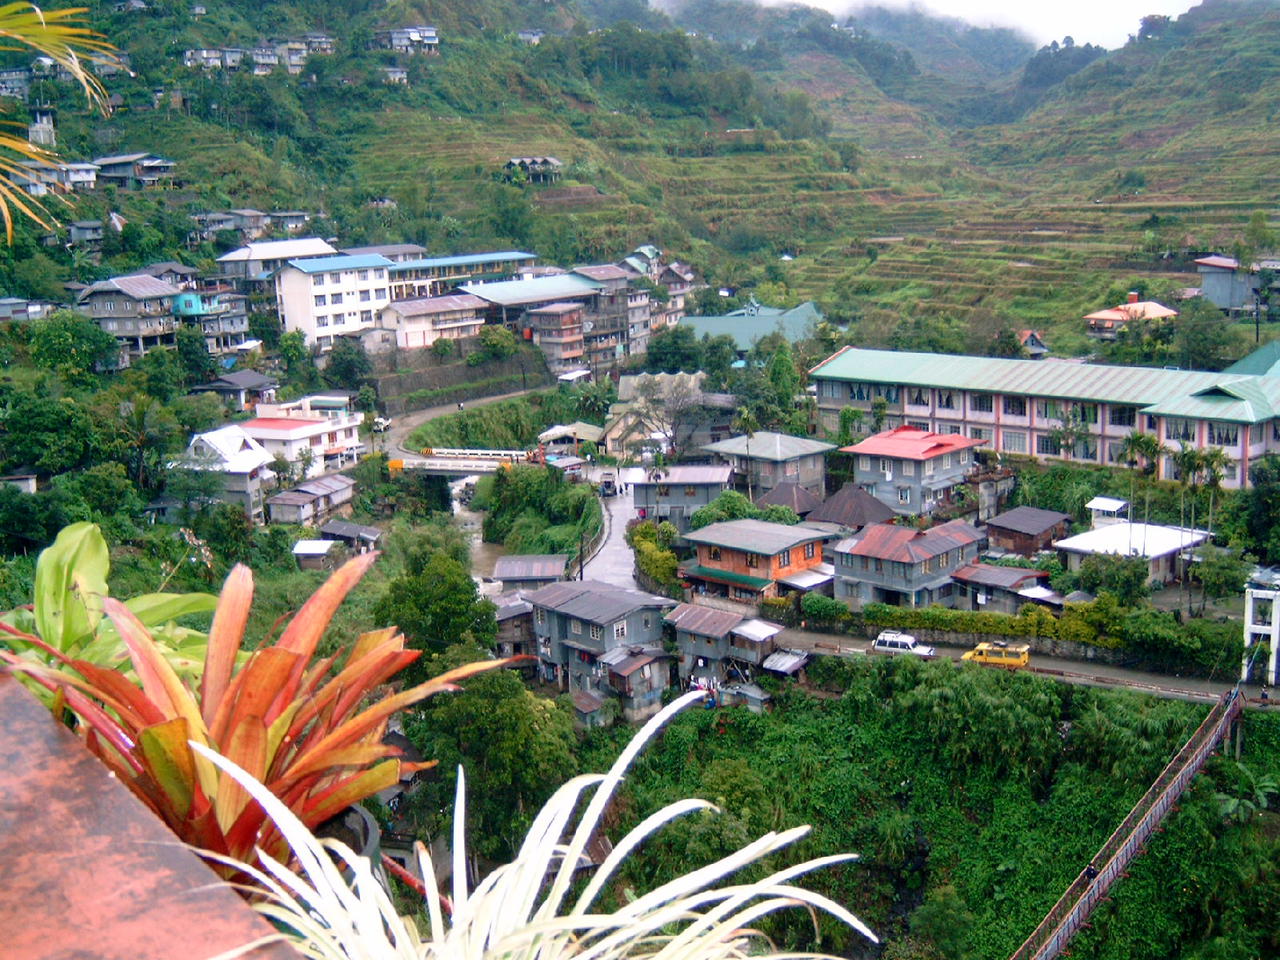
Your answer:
[239,393,365,479]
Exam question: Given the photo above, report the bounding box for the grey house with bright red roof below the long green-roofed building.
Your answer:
[840,426,982,513]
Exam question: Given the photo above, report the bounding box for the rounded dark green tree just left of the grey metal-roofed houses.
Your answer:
[374,553,498,682]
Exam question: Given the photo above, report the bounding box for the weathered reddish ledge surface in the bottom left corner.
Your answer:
[0,675,298,960]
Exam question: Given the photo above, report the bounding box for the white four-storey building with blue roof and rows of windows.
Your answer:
[275,253,392,351]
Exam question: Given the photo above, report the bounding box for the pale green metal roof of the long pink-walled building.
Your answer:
[808,347,1280,419]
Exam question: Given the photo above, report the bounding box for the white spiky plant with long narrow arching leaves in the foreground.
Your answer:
[192,691,877,960]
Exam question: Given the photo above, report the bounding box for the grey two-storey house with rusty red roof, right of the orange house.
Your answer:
[835,520,987,611]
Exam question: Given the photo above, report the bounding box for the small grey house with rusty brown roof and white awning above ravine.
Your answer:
[663,603,782,689]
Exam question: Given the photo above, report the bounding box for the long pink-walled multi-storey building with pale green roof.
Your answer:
[810,347,1280,488]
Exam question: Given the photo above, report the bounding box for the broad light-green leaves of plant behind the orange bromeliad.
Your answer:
[0,524,218,696]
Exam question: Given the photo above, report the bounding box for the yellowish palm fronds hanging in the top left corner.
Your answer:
[0,3,119,241]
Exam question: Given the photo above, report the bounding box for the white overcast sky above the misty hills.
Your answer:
[824,0,1196,49]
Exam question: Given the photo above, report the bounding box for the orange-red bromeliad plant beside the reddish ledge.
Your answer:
[0,553,506,874]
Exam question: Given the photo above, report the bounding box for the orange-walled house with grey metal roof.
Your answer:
[680,520,832,604]
